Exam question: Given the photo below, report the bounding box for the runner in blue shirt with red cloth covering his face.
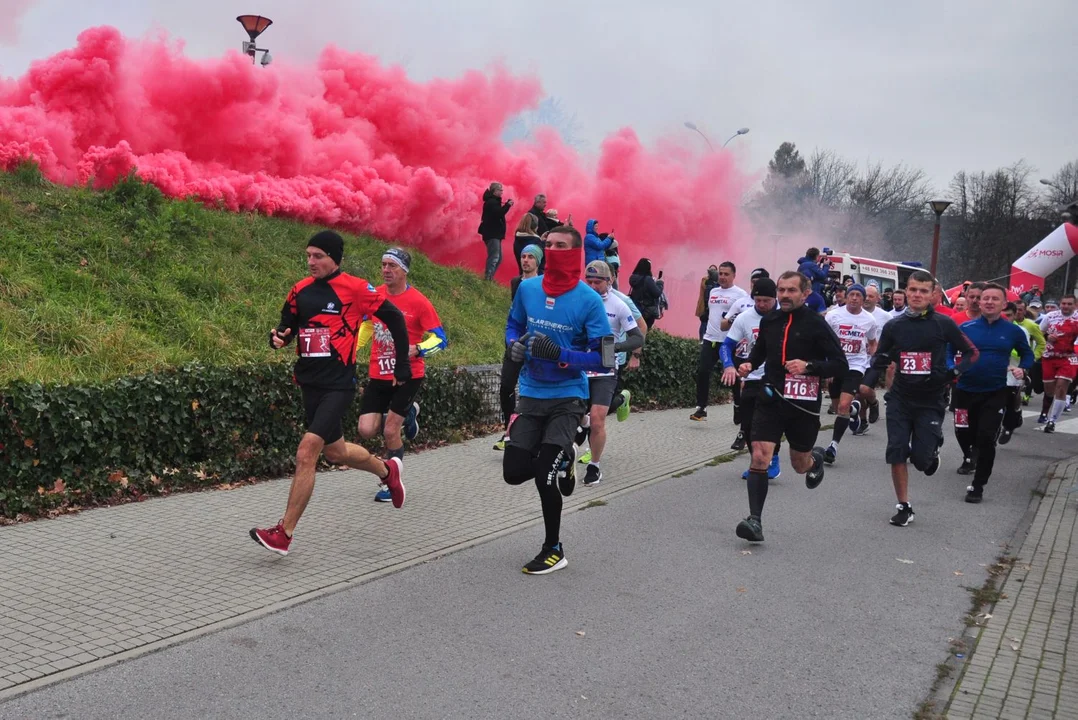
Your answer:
[502,225,614,574]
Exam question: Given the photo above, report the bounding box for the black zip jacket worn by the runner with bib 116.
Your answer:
[748,305,849,407]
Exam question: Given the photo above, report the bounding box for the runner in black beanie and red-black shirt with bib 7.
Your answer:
[250,231,412,555]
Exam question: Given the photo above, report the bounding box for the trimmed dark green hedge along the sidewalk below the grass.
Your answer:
[0,332,718,518]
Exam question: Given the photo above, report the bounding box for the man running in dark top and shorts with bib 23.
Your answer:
[865,271,977,527]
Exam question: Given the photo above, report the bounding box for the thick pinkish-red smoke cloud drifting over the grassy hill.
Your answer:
[0,27,745,334]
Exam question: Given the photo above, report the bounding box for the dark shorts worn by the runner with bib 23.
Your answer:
[883,390,946,471]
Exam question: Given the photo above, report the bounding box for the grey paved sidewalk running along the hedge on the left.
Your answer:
[0,406,735,700]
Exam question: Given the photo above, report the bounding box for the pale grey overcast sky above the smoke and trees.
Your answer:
[0,0,1078,191]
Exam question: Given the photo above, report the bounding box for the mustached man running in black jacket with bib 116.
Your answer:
[737,271,849,542]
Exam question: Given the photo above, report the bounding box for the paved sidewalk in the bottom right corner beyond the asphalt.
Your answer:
[946,458,1078,720]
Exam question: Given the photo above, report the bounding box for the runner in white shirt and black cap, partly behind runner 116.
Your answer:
[720,277,783,480]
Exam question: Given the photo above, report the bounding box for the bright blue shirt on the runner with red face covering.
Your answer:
[506,276,611,400]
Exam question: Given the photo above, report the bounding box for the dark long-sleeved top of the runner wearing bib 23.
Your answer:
[865,307,978,400]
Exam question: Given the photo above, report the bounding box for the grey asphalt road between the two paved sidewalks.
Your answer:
[0,413,1073,720]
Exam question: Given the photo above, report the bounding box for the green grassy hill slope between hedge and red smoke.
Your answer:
[0,164,509,383]
